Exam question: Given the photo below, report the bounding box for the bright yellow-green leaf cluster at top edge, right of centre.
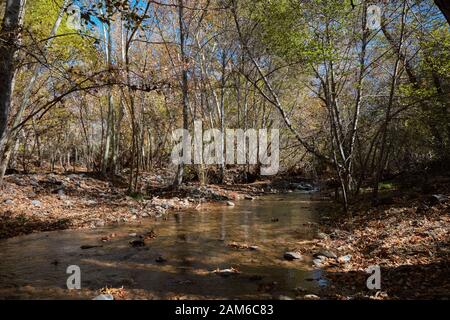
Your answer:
[251,0,349,62]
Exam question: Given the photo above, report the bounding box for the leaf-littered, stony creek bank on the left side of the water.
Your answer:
[0,173,316,239]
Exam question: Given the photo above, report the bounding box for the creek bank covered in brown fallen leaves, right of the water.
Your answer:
[301,179,450,300]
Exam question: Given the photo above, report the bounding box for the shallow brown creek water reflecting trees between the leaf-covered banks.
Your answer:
[0,194,320,299]
